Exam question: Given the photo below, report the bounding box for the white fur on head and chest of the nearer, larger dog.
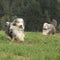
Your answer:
[10,18,25,41]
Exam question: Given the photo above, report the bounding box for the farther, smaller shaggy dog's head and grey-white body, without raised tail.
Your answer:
[43,23,56,35]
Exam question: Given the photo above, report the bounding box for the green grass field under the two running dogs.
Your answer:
[0,31,60,60]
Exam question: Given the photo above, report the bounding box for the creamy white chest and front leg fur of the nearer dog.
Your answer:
[10,25,25,41]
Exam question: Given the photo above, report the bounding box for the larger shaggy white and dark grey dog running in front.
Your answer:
[6,18,25,42]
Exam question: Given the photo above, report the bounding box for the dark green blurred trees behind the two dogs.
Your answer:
[0,0,60,31]
